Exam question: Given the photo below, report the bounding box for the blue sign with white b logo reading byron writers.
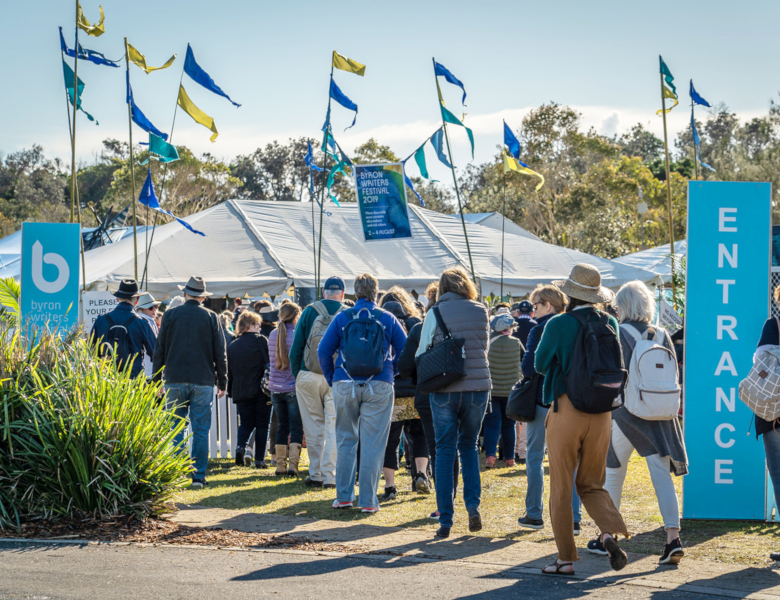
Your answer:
[21,223,80,331]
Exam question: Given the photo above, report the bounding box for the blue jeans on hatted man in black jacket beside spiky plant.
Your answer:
[165,383,214,479]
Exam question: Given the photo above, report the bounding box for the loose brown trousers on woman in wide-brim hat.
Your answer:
[545,394,628,562]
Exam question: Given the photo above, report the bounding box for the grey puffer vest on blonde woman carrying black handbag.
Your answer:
[426,292,492,393]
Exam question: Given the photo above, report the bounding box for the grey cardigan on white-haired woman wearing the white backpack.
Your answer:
[607,321,688,476]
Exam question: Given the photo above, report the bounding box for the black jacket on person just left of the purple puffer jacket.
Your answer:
[227,332,268,404]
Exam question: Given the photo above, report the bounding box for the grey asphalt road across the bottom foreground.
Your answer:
[0,543,722,600]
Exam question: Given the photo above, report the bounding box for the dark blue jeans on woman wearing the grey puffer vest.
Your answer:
[430,390,490,527]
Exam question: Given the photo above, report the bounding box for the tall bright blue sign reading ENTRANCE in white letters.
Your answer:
[683,181,772,519]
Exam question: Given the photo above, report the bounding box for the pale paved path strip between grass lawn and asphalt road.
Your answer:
[168,506,780,600]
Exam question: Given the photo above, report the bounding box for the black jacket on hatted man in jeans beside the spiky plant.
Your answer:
[152,300,227,390]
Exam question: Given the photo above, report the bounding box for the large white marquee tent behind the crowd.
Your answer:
[74,200,660,297]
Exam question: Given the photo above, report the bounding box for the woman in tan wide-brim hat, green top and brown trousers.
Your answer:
[534,264,628,575]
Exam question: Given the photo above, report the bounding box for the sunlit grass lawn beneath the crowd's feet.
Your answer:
[177,450,780,566]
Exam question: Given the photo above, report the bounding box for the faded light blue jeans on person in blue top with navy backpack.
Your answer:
[333,381,393,508]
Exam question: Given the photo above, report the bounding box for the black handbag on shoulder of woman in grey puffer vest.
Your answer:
[415,307,466,394]
